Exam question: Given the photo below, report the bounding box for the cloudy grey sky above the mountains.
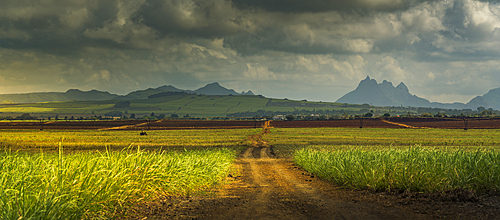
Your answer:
[0,0,500,103]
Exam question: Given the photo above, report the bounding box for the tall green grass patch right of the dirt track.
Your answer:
[293,147,500,192]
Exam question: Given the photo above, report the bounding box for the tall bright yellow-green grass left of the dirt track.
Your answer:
[0,149,235,219]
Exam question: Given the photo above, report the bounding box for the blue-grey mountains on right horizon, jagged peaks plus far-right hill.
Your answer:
[336,76,500,110]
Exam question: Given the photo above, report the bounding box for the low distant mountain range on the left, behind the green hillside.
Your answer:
[0,82,254,104]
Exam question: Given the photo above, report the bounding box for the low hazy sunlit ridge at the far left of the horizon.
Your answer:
[0,89,118,103]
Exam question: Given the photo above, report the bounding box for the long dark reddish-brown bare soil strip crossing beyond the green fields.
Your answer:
[0,118,500,130]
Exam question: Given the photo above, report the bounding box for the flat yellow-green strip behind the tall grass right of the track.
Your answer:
[263,128,500,157]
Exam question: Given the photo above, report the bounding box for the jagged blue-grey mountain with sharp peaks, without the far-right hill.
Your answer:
[337,76,468,109]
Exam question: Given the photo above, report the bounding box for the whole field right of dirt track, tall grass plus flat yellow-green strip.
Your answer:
[265,128,500,192]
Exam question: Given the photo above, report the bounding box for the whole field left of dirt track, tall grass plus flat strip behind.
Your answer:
[0,129,260,219]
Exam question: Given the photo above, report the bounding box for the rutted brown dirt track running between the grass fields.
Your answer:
[133,123,431,219]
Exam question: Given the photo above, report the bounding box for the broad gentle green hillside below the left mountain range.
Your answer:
[0,92,412,118]
